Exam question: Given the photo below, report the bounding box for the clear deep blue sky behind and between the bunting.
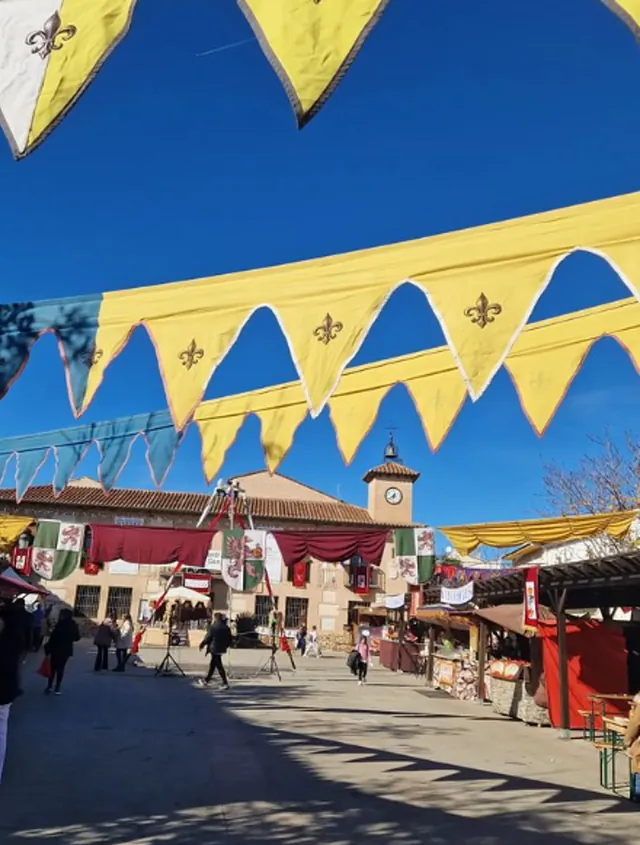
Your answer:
[0,0,640,536]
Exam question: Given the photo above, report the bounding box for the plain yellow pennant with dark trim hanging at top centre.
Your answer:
[238,0,389,127]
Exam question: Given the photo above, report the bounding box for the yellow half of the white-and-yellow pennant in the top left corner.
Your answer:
[26,0,137,155]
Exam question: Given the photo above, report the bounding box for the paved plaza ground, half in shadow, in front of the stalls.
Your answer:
[0,647,640,845]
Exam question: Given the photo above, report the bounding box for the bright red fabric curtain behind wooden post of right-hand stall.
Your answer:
[538,620,629,728]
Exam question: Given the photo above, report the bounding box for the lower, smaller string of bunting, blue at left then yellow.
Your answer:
[0,298,640,500]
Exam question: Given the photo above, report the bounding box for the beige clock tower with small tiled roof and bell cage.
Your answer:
[363,435,420,525]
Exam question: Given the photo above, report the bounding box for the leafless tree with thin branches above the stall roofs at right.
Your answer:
[542,431,640,557]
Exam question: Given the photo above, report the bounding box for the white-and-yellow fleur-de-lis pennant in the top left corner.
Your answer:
[0,0,136,158]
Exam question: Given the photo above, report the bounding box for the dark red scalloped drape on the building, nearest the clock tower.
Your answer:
[273,530,389,566]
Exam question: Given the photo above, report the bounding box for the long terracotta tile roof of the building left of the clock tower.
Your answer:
[0,485,388,525]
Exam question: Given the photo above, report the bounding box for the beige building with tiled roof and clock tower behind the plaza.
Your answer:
[0,462,419,643]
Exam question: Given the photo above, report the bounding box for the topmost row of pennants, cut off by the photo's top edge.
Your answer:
[0,0,640,158]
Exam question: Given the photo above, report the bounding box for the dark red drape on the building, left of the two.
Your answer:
[88,524,215,567]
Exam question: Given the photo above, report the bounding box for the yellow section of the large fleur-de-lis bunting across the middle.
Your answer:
[80,193,640,428]
